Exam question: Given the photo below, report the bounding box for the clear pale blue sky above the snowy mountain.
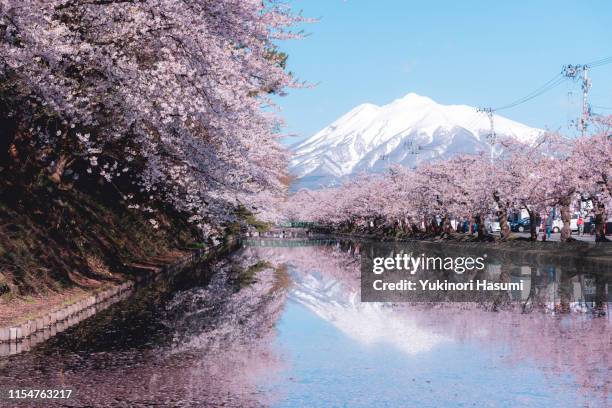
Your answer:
[278,0,612,143]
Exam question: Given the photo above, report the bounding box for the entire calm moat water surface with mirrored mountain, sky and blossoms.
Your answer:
[0,237,612,407]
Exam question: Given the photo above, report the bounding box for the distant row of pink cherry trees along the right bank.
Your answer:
[286,117,612,241]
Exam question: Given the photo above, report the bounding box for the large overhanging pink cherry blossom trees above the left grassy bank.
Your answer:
[0,0,302,239]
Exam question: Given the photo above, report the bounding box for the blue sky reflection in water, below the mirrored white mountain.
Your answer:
[272,301,580,407]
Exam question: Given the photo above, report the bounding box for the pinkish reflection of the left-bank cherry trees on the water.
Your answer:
[0,253,286,407]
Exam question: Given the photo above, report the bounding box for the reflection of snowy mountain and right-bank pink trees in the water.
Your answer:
[246,242,612,405]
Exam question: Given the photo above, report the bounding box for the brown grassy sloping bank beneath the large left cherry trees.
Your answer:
[0,177,203,341]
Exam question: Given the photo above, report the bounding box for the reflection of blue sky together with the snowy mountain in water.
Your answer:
[262,268,598,407]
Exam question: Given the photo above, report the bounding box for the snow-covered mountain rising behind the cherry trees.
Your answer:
[290,93,543,189]
